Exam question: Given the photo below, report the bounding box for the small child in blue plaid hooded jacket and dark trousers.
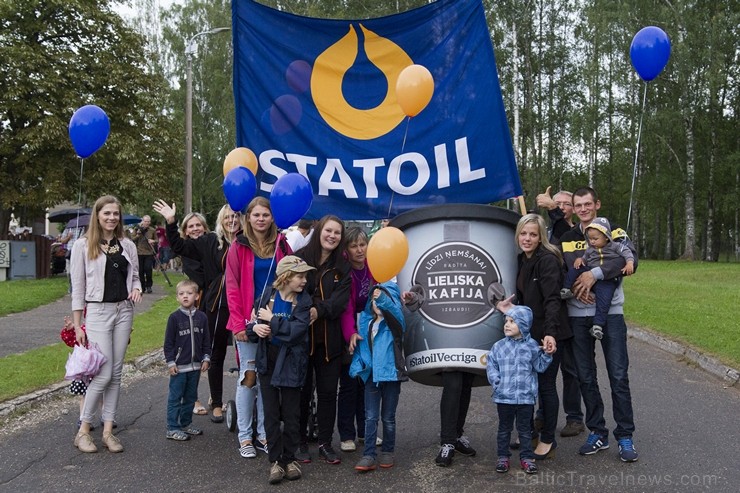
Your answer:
[486,305,552,474]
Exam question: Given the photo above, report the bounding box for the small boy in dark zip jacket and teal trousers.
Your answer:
[164,279,211,441]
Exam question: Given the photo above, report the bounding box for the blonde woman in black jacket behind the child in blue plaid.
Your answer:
[497,214,573,460]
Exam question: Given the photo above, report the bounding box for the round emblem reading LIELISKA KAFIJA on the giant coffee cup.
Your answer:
[412,242,501,328]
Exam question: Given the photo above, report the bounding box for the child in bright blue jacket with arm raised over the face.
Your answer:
[349,282,408,472]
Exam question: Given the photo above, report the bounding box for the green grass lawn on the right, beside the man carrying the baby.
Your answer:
[624,261,740,368]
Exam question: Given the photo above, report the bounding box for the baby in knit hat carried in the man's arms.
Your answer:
[560,217,635,339]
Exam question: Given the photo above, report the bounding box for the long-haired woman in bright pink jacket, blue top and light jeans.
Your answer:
[226,197,292,458]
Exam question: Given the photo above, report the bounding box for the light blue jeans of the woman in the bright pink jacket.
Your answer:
[234,341,267,443]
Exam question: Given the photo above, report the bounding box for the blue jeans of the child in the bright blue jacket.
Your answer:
[363,376,401,457]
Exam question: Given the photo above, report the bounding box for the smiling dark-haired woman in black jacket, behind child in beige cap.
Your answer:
[296,215,352,464]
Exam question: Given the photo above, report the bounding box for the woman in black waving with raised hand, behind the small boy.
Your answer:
[152,200,241,423]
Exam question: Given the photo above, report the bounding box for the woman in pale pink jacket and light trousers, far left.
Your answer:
[70,195,141,452]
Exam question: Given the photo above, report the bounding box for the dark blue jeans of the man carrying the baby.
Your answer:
[570,315,635,440]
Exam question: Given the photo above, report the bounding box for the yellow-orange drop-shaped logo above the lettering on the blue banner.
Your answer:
[311,24,414,140]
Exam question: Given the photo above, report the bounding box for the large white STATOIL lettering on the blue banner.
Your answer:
[259,137,486,199]
